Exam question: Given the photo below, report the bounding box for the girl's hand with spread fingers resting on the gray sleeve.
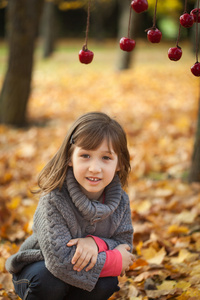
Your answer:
[67,237,98,272]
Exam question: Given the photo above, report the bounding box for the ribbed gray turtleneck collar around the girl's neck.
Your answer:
[66,168,122,223]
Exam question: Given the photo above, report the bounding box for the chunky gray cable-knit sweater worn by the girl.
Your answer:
[6,168,133,291]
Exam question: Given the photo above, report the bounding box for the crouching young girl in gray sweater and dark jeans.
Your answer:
[6,112,134,300]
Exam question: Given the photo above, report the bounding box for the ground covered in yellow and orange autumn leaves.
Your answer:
[0,41,200,300]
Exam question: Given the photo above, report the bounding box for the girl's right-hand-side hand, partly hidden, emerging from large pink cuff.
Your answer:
[115,244,135,276]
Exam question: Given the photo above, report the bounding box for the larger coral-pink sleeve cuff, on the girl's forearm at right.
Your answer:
[100,249,122,277]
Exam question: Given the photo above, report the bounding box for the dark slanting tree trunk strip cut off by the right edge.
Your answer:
[189,99,200,182]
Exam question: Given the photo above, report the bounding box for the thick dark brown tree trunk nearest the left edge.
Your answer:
[0,0,44,126]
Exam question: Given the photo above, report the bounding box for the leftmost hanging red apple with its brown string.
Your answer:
[79,0,94,64]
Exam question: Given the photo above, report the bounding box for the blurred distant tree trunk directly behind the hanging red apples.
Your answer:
[117,0,140,70]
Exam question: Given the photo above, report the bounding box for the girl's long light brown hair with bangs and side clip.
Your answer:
[36,112,130,194]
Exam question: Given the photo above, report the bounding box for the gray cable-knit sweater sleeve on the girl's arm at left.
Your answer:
[34,194,106,291]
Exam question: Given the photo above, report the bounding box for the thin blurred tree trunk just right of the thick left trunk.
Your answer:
[42,2,57,58]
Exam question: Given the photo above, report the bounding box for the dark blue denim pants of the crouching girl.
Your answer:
[13,261,119,300]
